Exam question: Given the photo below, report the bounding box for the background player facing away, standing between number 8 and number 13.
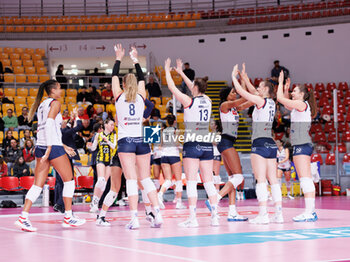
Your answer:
[158,115,186,209]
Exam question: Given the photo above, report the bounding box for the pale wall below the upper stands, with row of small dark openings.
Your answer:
[0,24,350,83]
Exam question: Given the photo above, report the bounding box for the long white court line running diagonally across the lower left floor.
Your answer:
[0,227,204,262]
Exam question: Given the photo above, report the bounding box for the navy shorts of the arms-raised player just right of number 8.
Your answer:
[182,142,214,161]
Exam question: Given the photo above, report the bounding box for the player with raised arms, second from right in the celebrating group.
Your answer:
[232,65,284,224]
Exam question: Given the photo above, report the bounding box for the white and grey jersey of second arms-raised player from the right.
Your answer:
[252,98,276,140]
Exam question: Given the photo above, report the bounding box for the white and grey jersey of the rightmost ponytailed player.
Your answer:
[290,102,311,145]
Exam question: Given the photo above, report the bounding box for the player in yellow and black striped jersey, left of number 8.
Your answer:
[90,119,119,213]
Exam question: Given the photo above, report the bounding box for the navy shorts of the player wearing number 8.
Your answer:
[118,137,151,155]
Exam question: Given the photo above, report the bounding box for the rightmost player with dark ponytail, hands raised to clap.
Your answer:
[277,72,318,222]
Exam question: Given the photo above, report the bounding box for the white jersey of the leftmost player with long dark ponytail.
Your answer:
[36,98,63,146]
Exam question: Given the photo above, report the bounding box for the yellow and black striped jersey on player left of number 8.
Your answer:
[96,132,117,162]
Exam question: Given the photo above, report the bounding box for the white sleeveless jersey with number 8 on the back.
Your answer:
[115,93,145,140]
